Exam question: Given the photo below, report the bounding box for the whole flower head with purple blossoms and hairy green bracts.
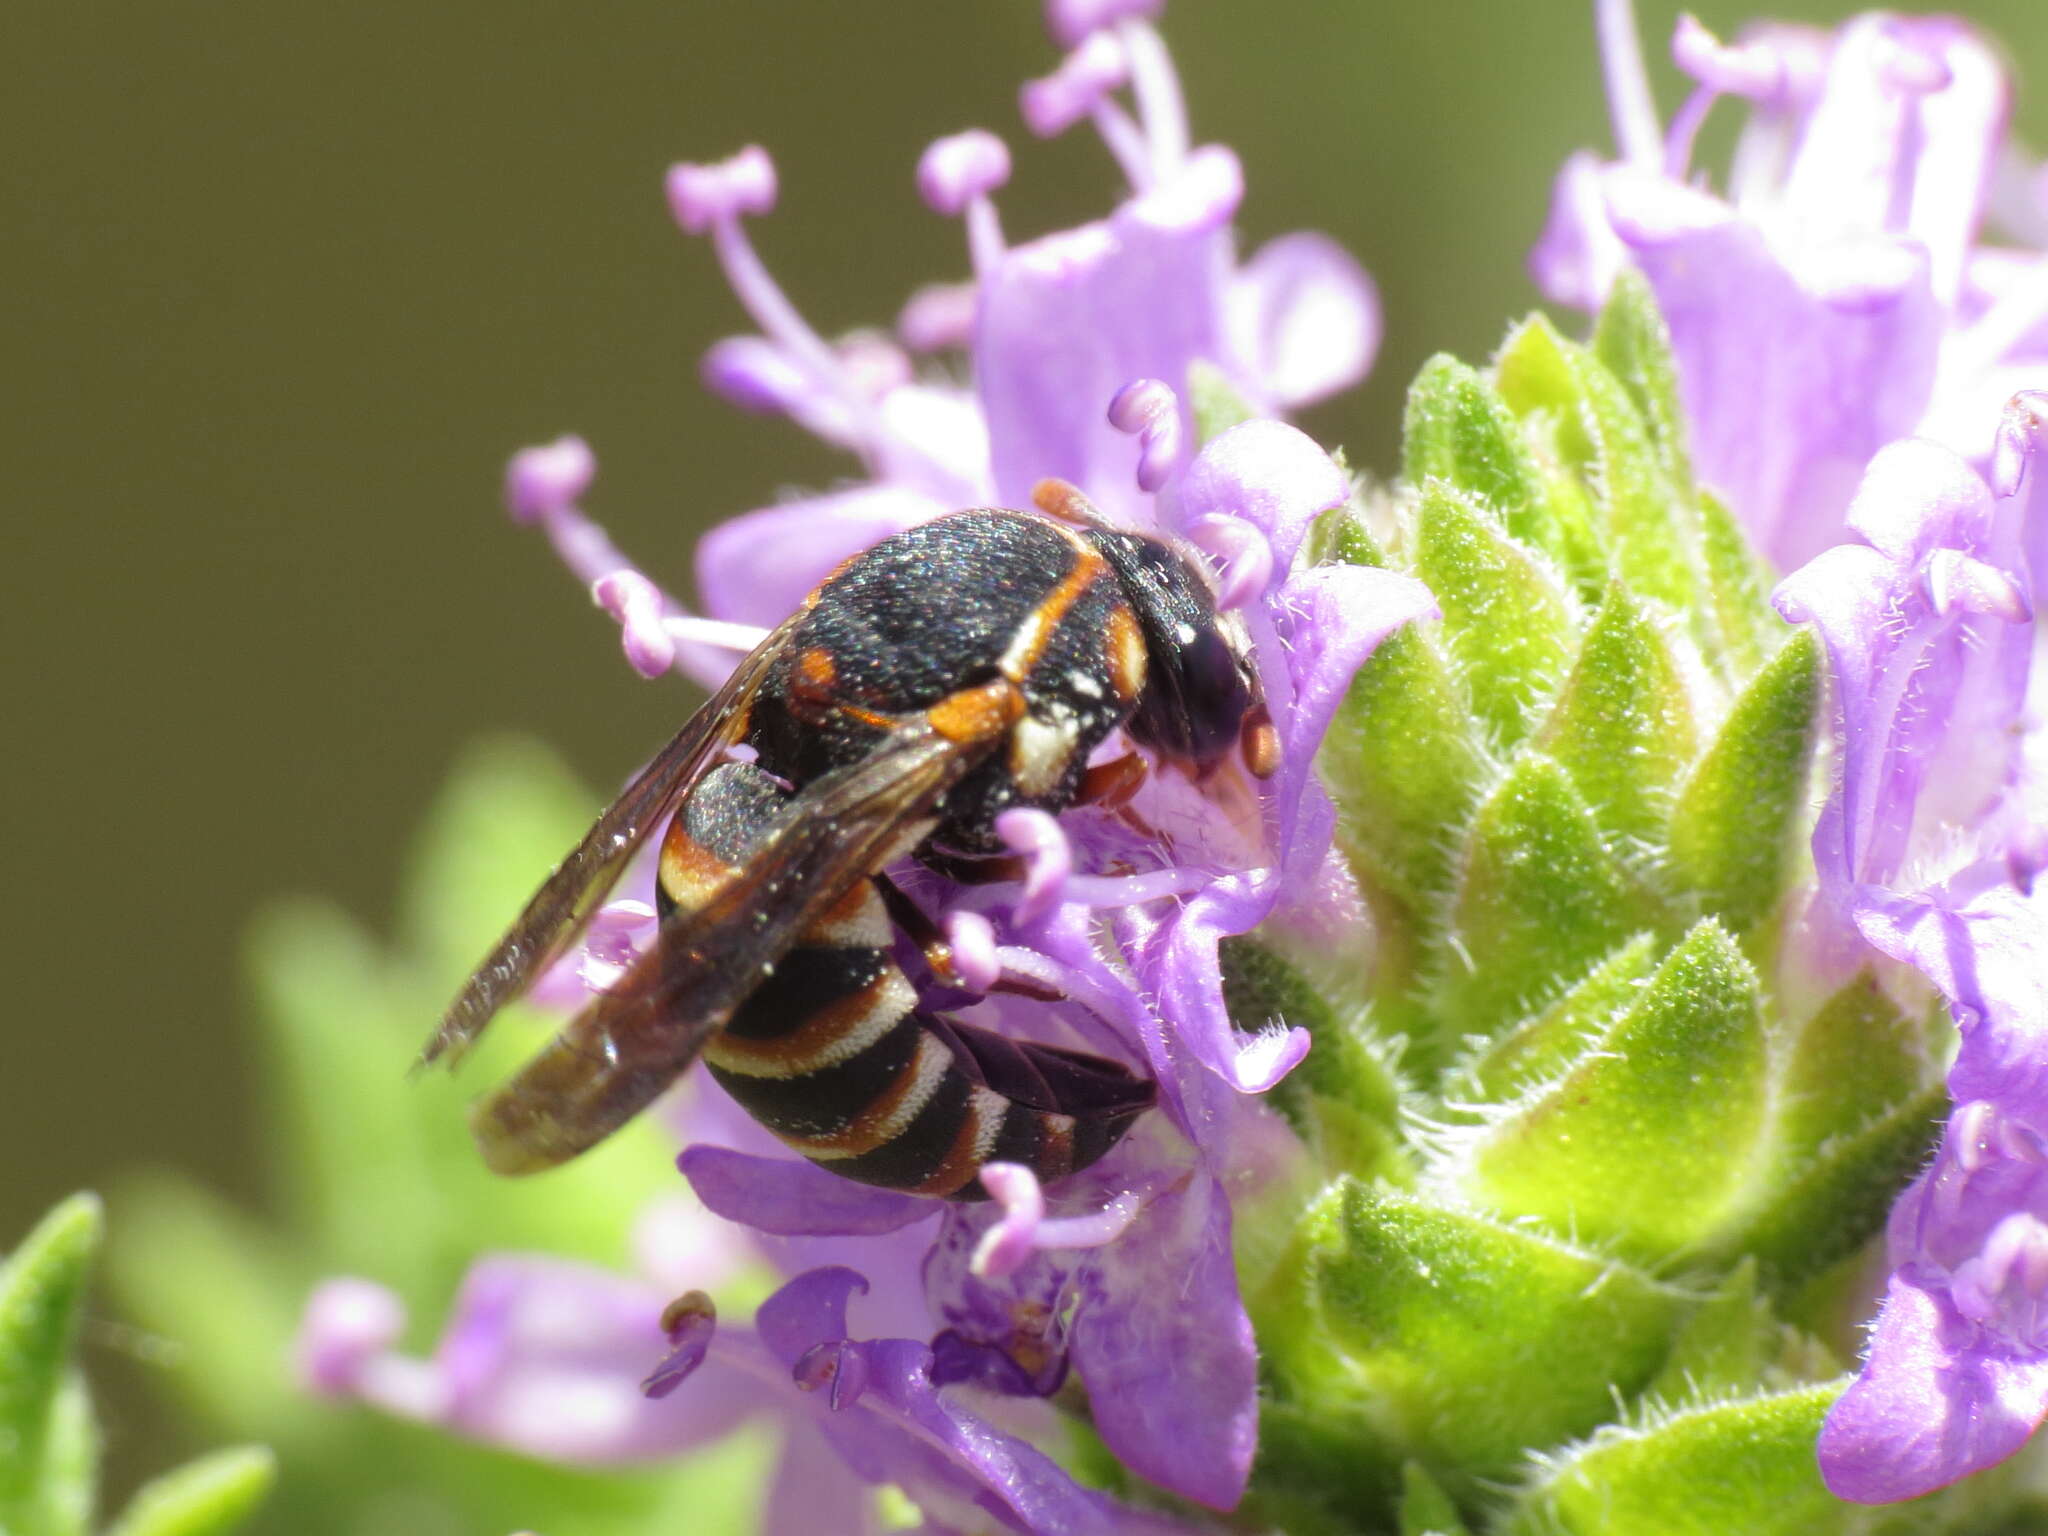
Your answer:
[239,0,2048,1536]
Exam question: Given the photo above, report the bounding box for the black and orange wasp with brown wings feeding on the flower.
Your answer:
[424,481,1278,1198]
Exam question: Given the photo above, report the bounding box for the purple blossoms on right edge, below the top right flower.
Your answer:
[1778,415,2048,1503]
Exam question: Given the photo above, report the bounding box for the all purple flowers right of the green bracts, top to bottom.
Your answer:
[1534,2,2048,1501]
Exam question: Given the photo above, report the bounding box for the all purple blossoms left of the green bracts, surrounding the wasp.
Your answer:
[301,0,1432,1532]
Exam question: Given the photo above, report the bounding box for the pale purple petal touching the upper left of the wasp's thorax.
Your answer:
[696,485,937,627]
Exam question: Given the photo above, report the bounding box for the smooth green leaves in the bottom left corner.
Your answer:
[0,1194,274,1536]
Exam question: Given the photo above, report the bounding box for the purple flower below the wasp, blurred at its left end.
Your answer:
[301,1257,1188,1536]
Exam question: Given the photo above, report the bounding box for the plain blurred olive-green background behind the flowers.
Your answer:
[0,0,2048,1515]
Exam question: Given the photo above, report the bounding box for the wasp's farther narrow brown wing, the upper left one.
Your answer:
[420,618,797,1065]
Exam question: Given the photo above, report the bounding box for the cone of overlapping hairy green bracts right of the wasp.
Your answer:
[1227,279,1944,1536]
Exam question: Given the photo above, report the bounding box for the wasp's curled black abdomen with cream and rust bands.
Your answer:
[657,764,1153,1200]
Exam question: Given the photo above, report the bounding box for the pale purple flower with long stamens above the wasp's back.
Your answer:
[514,6,1380,676]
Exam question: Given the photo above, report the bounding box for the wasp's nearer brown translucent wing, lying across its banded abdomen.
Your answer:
[471,696,1008,1174]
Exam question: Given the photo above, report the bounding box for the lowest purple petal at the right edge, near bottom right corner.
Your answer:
[1819,1270,2048,1503]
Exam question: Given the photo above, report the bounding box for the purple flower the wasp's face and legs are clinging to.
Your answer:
[682,411,1434,1507]
